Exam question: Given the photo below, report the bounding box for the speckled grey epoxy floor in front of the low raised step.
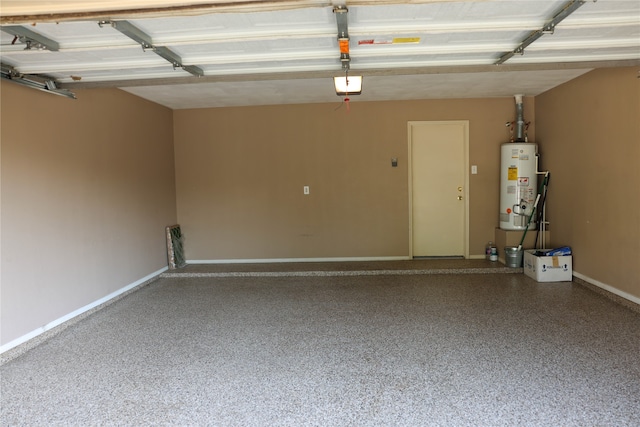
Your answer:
[0,269,640,426]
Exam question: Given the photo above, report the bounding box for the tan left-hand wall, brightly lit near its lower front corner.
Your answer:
[0,83,176,345]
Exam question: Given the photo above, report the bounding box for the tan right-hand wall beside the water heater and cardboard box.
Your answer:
[535,67,640,298]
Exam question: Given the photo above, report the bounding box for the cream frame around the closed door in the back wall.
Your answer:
[407,120,469,259]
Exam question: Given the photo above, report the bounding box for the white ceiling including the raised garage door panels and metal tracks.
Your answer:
[0,0,640,109]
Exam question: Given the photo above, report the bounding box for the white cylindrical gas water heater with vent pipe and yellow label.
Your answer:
[500,95,538,230]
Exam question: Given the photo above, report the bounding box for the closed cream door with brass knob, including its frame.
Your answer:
[409,121,469,258]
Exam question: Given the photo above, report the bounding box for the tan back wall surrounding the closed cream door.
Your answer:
[174,97,535,260]
